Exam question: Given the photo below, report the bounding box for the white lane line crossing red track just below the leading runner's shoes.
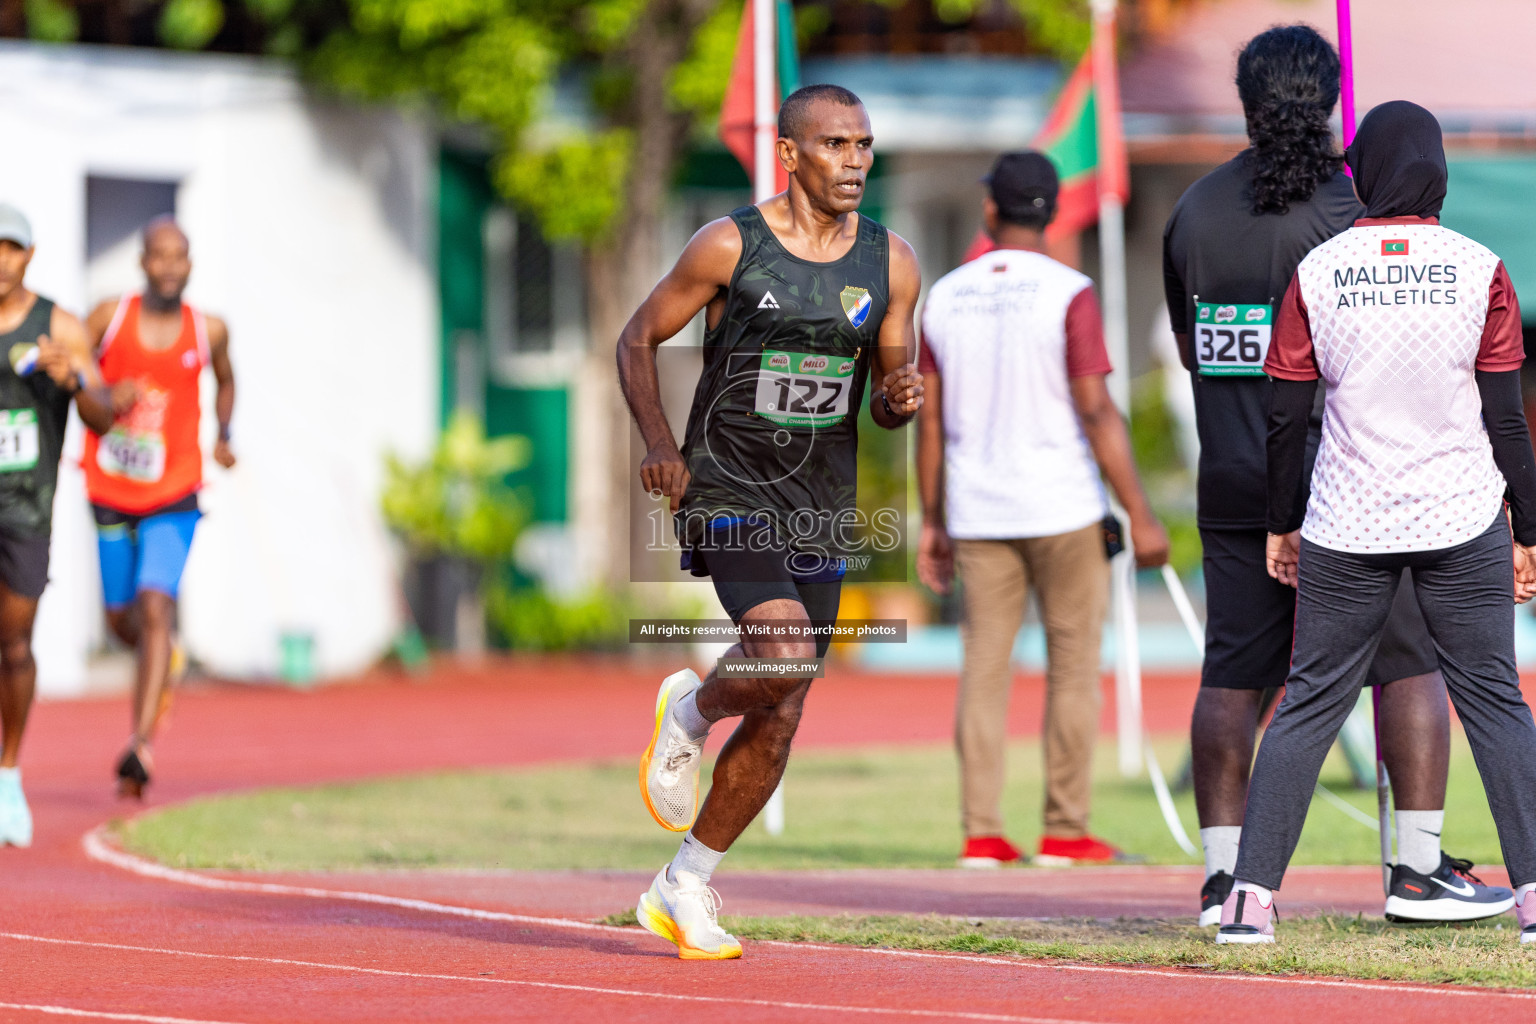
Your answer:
[0,929,1111,1024]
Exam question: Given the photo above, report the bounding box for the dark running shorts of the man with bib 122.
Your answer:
[684,524,843,657]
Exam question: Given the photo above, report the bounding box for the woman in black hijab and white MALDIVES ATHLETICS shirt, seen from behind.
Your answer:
[1217,101,1536,943]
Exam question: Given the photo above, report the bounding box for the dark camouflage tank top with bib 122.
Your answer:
[674,206,889,554]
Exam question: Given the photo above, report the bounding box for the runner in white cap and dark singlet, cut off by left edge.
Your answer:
[0,204,112,846]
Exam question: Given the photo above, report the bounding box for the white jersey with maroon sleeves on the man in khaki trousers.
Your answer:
[919,249,1111,540]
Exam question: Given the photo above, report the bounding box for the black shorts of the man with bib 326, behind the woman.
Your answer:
[1200,530,1439,689]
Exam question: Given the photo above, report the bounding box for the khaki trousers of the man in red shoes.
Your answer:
[955,522,1109,838]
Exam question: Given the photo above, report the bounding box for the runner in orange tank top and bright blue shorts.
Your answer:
[84,218,235,797]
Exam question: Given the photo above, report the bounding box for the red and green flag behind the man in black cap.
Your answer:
[966,19,1130,261]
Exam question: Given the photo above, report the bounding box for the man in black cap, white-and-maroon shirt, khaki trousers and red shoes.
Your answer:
[917,152,1167,867]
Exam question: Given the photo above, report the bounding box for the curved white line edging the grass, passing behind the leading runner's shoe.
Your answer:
[83,826,1536,999]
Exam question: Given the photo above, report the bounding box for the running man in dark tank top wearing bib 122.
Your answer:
[619,86,923,960]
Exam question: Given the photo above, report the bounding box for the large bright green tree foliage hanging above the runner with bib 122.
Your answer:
[304,0,740,243]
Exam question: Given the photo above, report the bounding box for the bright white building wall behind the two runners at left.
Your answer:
[0,43,439,694]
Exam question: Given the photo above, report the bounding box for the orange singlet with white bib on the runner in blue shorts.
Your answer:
[84,295,209,514]
